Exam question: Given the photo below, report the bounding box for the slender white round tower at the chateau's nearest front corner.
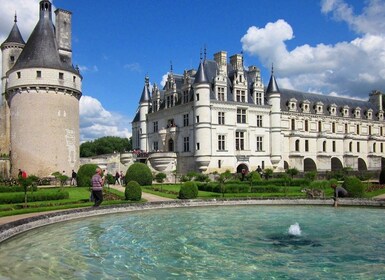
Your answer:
[193,61,211,172]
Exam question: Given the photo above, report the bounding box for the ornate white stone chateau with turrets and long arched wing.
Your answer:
[132,51,385,173]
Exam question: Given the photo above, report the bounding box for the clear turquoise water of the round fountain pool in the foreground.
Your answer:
[0,206,385,279]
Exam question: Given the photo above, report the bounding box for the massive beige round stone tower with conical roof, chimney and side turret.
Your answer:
[1,0,82,177]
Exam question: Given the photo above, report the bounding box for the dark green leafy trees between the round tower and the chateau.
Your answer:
[80,136,132,157]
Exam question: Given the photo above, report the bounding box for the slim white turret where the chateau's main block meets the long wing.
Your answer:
[266,65,283,167]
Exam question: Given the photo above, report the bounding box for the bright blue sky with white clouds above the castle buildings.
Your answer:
[0,0,385,141]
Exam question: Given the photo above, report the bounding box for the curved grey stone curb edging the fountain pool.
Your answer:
[0,198,385,243]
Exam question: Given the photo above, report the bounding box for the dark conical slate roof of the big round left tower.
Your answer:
[12,1,77,73]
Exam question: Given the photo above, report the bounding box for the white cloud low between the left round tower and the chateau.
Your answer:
[80,95,131,142]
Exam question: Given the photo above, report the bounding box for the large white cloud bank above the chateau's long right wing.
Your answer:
[241,0,385,98]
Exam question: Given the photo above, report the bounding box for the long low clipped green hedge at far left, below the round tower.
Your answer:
[0,190,69,204]
